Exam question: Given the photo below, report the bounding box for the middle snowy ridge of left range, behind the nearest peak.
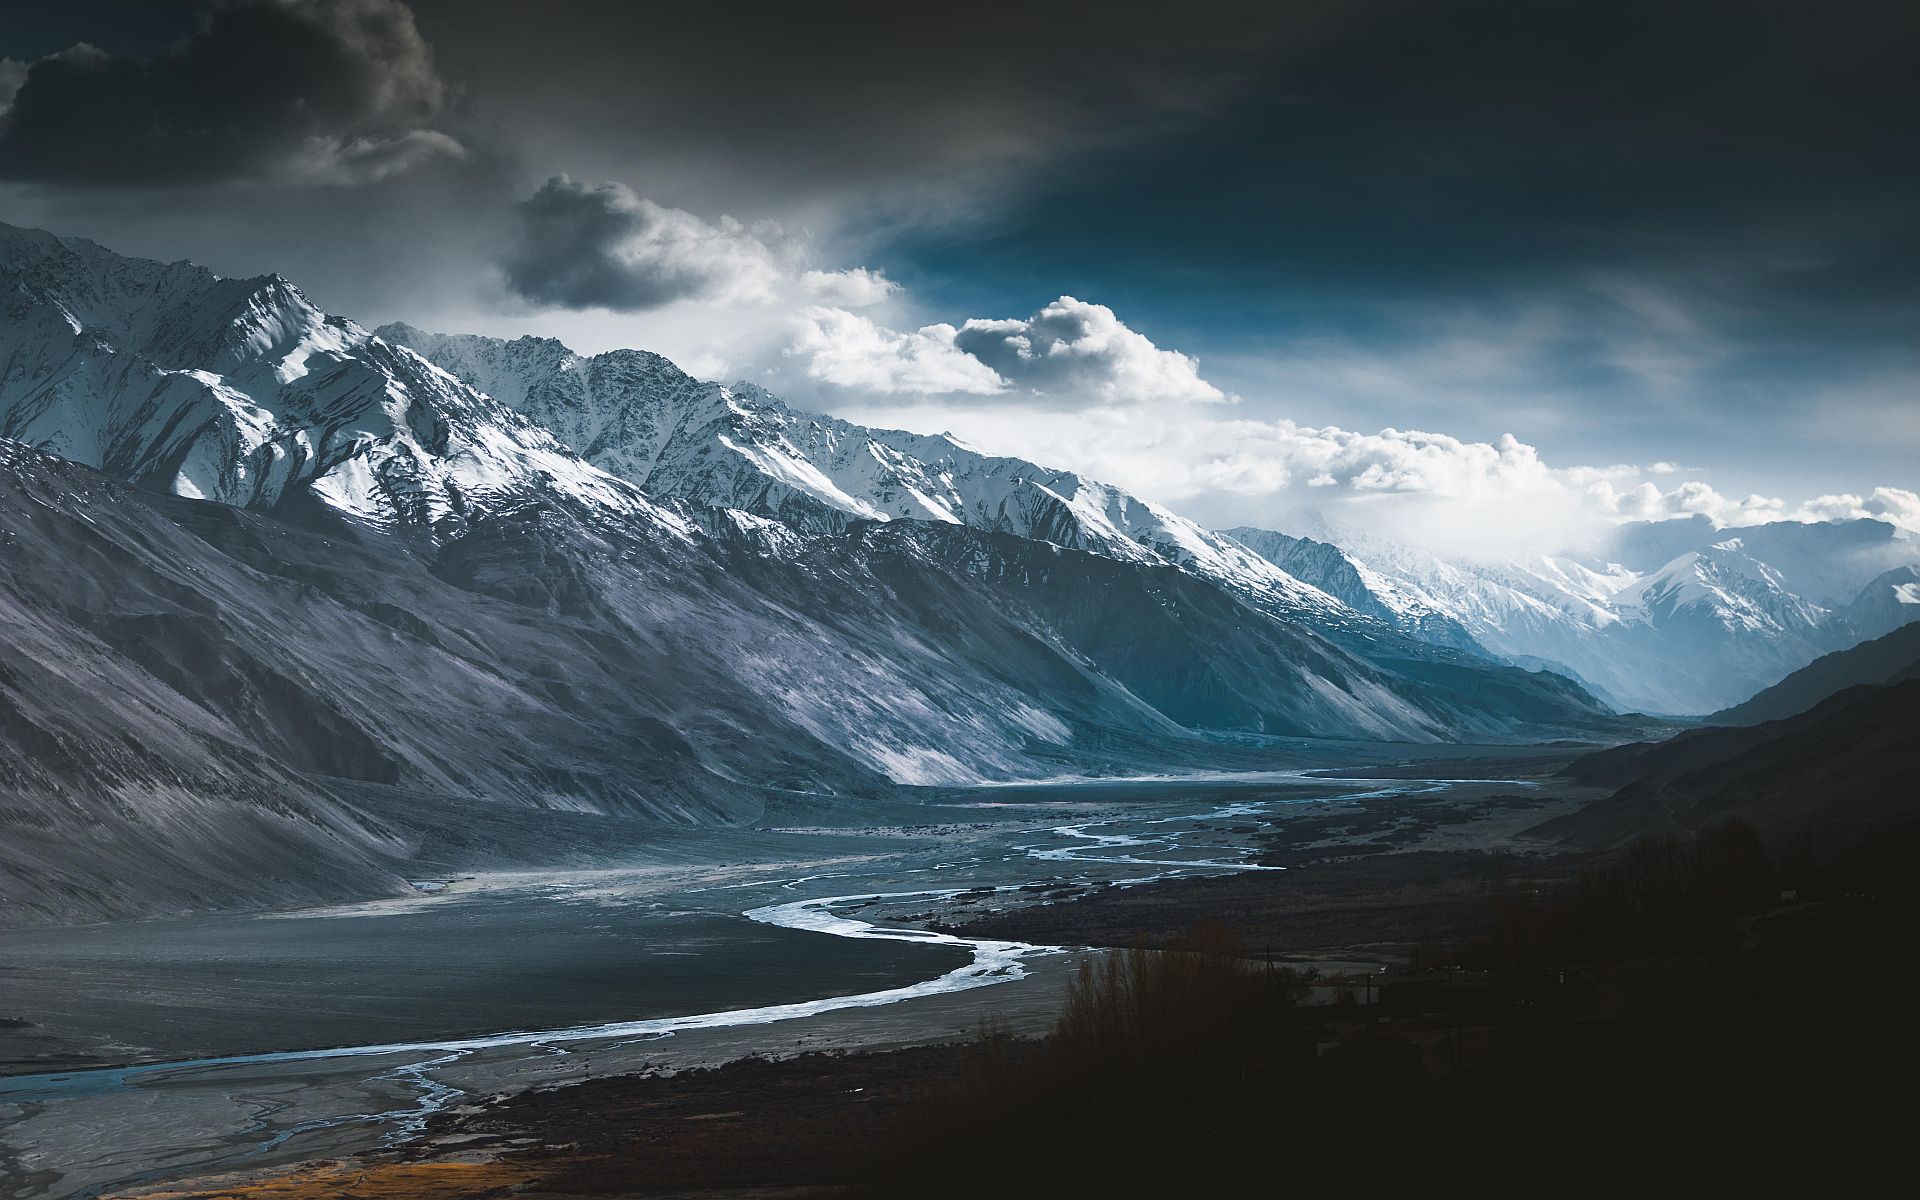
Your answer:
[378,324,1512,657]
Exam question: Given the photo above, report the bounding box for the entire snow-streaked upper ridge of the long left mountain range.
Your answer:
[0,220,1620,737]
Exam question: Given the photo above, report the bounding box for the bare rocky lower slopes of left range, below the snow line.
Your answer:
[0,435,1611,922]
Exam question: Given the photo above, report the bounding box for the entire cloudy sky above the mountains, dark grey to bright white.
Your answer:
[0,0,1920,547]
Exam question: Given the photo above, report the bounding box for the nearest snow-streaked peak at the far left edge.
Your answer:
[0,225,662,532]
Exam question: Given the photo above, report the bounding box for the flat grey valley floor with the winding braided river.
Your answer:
[0,760,1578,1198]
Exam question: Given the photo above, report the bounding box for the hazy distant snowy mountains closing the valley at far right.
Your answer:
[1235,518,1920,714]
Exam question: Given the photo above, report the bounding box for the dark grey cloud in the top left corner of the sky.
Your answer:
[0,0,467,184]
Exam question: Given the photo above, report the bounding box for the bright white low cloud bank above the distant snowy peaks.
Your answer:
[847,397,1920,559]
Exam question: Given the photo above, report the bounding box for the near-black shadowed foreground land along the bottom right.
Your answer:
[120,826,1920,1200]
